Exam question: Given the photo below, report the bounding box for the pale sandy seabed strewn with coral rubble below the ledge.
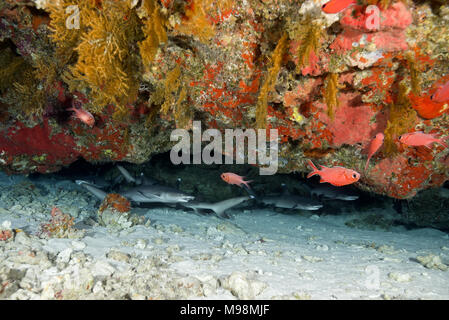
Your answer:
[0,174,449,299]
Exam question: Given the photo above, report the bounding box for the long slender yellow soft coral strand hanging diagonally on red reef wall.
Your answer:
[256,33,288,128]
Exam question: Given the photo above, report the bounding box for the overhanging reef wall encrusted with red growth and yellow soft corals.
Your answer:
[0,0,449,198]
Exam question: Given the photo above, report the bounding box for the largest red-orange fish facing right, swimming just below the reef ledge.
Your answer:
[307,160,360,187]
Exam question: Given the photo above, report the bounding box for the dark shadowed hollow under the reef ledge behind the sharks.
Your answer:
[29,152,449,232]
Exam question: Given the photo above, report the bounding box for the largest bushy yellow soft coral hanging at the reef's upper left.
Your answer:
[66,1,139,109]
